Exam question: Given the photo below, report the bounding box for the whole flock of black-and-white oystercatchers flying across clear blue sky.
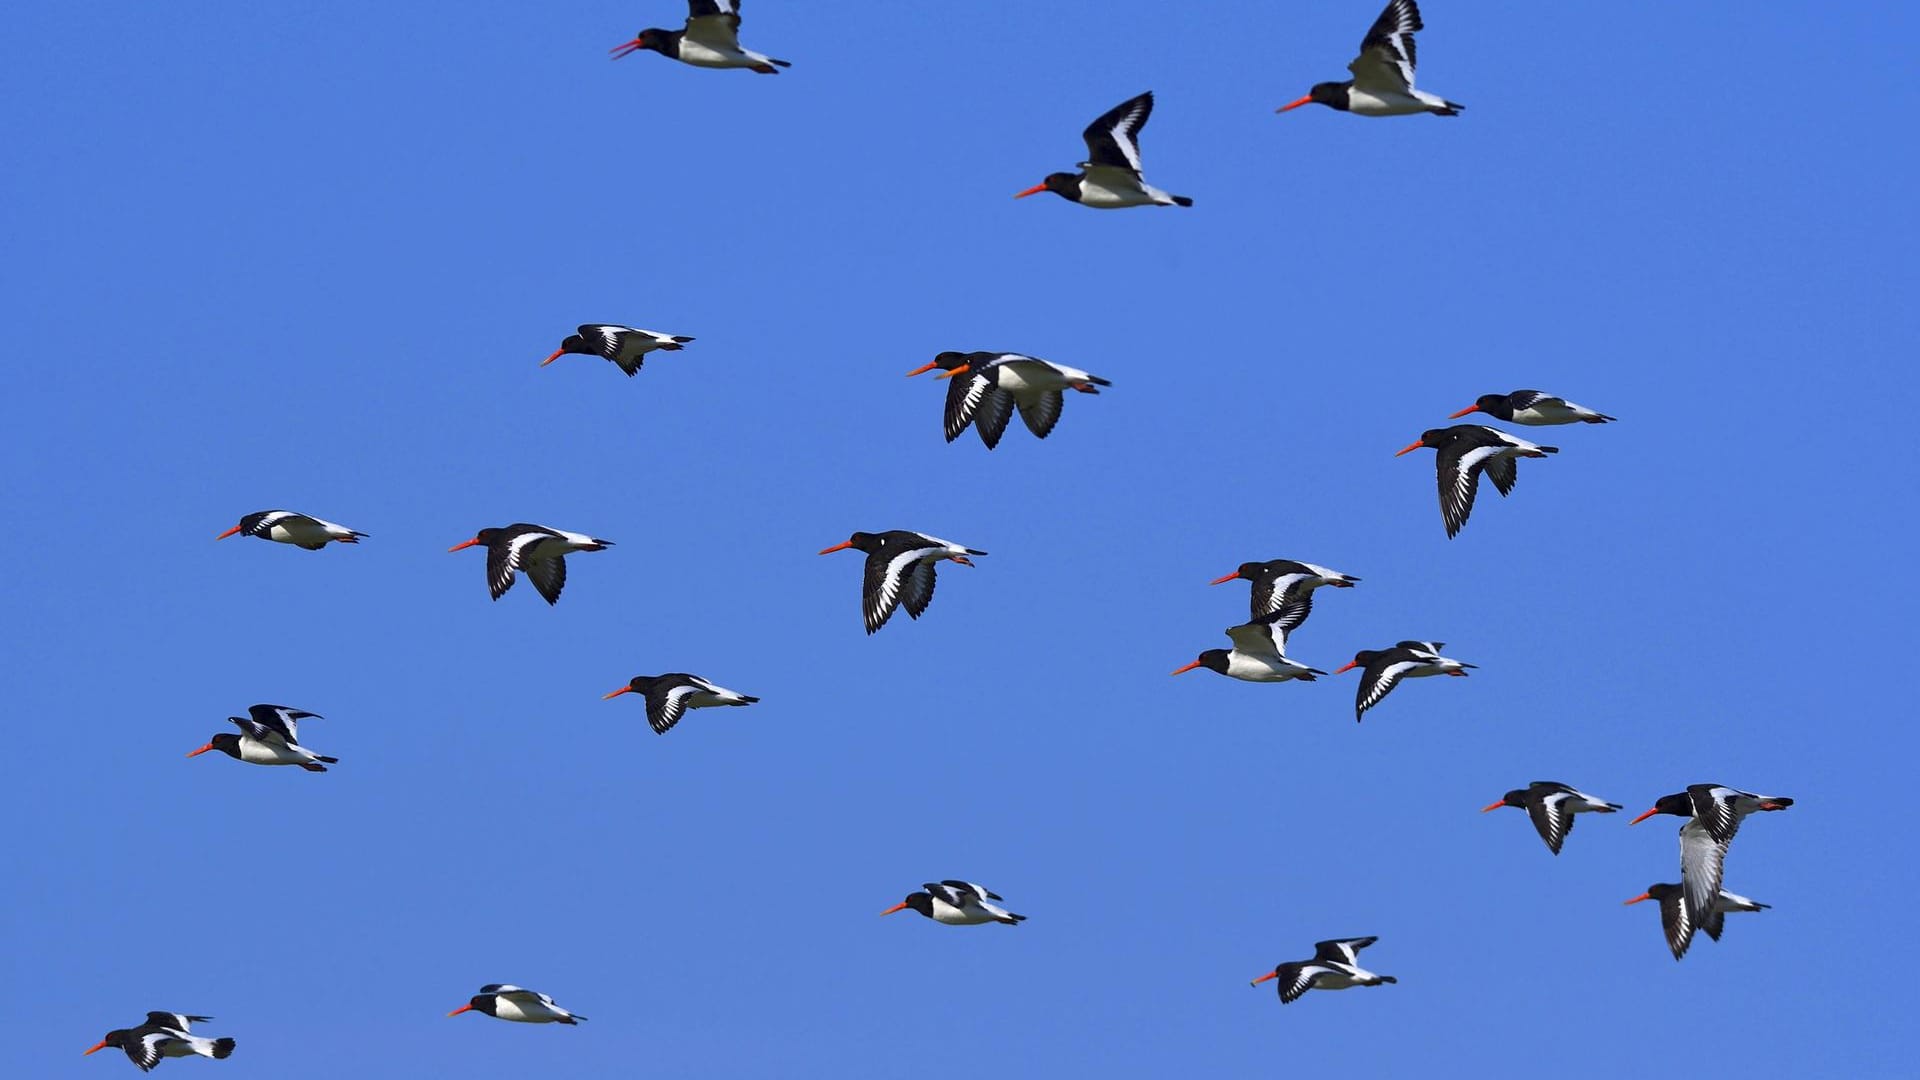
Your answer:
[86,0,1793,1070]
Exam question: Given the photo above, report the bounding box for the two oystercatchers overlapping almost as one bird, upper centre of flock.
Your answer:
[906,352,1112,450]
